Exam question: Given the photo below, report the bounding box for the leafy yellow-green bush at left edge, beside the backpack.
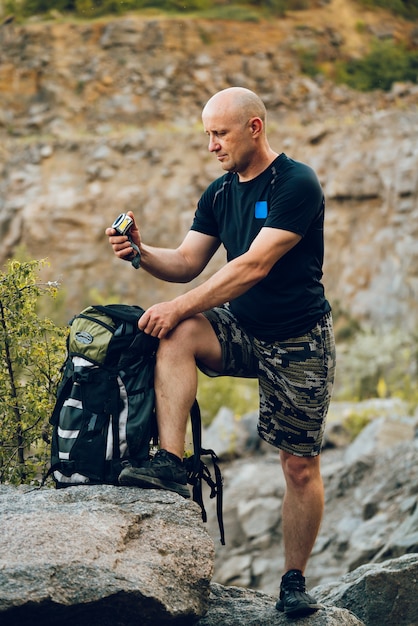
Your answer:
[0,261,66,484]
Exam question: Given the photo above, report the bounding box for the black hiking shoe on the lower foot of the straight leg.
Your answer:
[276,569,322,617]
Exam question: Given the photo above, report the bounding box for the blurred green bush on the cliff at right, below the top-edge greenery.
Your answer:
[336,40,418,91]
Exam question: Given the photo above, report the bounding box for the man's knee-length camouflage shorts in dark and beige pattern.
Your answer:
[199,307,335,456]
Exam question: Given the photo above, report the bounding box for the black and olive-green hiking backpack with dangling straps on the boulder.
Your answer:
[45,304,224,545]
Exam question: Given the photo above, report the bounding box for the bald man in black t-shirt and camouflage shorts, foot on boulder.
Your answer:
[106,87,335,616]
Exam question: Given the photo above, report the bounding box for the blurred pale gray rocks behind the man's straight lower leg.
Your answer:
[203,399,418,592]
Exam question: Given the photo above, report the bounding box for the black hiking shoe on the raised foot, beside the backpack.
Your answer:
[118,450,190,498]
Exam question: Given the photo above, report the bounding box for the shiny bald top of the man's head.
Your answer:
[202,87,266,125]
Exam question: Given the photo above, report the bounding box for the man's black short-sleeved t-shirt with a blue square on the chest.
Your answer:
[191,153,330,341]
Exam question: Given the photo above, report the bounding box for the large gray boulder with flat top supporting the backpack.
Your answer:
[0,486,214,626]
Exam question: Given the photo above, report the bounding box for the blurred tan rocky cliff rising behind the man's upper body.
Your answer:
[0,0,418,329]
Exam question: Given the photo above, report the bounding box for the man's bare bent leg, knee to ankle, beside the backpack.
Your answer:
[155,315,222,458]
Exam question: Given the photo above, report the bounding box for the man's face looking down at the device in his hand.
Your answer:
[202,107,254,174]
